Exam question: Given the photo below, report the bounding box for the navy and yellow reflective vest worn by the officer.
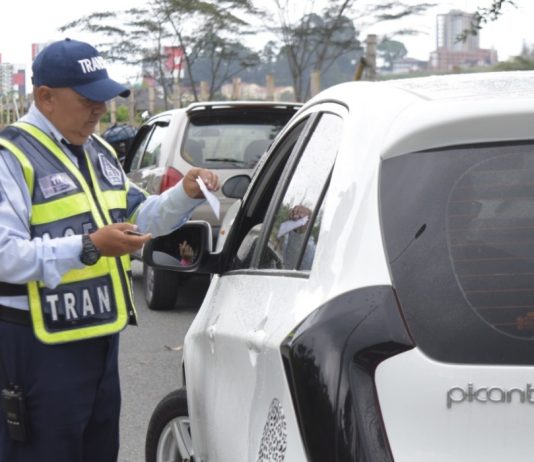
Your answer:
[0,122,135,344]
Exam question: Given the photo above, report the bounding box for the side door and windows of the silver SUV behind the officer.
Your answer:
[125,116,170,194]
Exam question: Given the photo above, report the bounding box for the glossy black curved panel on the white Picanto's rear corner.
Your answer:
[281,286,414,462]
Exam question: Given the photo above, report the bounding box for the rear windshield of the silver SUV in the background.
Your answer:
[181,109,294,169]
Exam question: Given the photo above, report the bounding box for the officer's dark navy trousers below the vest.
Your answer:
[0,321,121,462]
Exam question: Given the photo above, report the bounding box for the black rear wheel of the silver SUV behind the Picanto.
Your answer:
[143,265,180,311]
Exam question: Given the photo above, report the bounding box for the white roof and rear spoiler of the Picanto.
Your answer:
[301,71,534,160]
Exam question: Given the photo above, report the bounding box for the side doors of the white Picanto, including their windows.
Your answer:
[184,103,345,462]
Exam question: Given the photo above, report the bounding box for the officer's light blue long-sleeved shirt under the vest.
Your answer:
[0,104,203,310]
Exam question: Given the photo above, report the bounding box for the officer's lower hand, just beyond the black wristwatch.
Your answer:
[89,223,152,257]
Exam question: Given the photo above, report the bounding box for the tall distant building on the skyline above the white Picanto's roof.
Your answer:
[430,10,498,71]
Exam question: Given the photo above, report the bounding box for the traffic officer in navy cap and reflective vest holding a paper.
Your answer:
[0,39,219,462]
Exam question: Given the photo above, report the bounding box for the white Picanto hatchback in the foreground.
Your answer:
[144,72,534,462]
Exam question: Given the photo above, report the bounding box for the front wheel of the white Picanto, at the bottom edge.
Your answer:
[145,388,193,462]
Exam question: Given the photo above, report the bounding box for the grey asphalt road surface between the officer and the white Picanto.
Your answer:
[119,261,197,462]
